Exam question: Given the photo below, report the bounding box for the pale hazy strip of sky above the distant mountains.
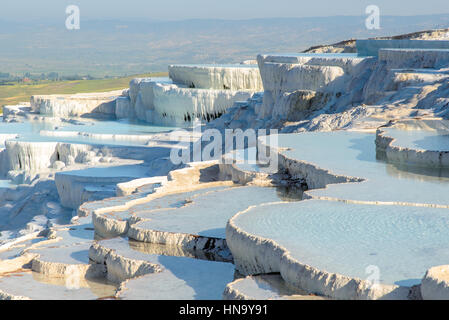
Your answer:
[0,0,449,20]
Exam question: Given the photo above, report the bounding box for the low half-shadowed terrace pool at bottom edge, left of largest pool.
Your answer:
[90,238,234,300]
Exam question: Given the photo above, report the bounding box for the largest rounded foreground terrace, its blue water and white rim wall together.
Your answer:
[226,200,449,299]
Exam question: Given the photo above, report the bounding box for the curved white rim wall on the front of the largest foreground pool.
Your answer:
[226,202,410,300]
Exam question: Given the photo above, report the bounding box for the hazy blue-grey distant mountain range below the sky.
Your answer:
[0,14,449,77]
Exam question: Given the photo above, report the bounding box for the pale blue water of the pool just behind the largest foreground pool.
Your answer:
[278,131,449,205]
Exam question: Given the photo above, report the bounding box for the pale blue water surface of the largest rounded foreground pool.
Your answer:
[235,200,449,286]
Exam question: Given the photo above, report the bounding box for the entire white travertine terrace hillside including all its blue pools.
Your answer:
[0,30,449,300]
